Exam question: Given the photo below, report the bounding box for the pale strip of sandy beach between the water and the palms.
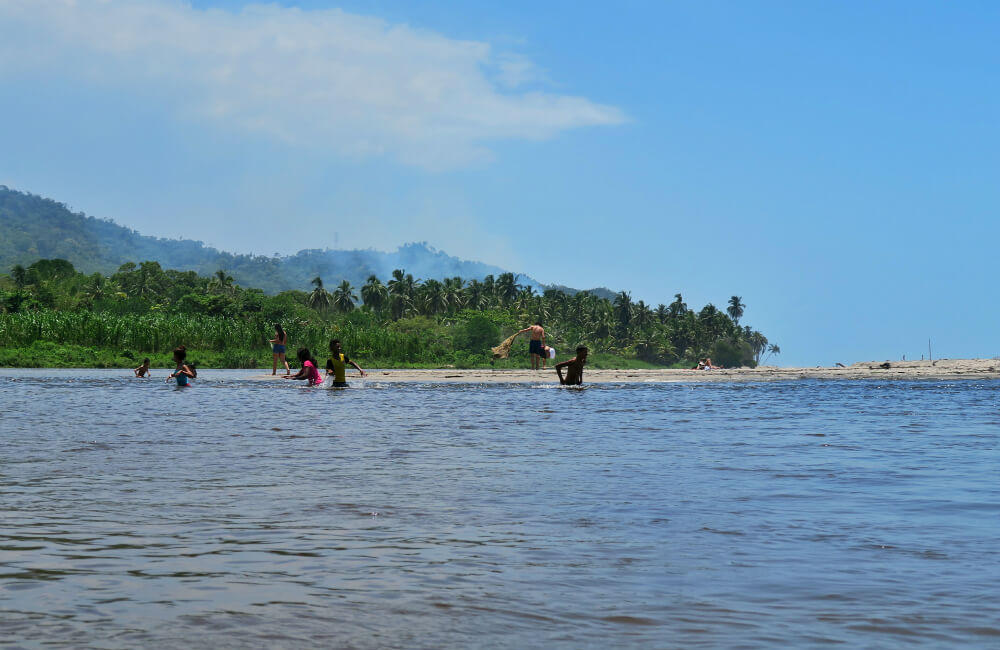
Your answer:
[252,359,1000,384]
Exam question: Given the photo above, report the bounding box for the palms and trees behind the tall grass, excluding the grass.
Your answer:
[0,259,780,367]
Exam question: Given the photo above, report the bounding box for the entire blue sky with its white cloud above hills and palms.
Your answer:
[0,0,1000,366]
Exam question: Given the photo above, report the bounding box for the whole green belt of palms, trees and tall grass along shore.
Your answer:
[0,259,780,368]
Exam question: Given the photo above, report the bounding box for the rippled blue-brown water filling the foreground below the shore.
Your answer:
[0,370,1000,648]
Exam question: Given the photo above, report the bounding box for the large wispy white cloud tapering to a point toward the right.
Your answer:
[0,0,625,168]
